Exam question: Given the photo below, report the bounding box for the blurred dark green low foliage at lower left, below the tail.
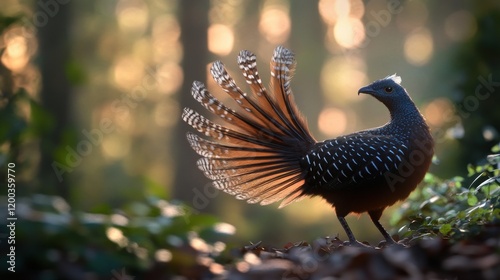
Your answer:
[2,194,234,279]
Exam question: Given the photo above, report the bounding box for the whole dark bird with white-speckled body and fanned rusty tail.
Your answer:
[183,47,433,244]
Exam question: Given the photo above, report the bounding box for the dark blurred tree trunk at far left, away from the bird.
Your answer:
[37,1,72,199]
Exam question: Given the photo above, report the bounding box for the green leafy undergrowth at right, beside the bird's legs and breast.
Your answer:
[391,144,500,241]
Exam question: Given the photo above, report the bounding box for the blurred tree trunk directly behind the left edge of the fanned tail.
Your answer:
[173,0,213,210]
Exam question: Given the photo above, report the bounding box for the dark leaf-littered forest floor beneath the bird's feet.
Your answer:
[215,225,500,280]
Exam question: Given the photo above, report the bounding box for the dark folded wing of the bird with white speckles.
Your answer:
[302,134,408,189]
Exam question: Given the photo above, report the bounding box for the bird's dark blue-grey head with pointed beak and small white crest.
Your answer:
[358,74,413,113]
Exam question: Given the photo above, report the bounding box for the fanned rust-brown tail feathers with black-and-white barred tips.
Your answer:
[182,46,316,207]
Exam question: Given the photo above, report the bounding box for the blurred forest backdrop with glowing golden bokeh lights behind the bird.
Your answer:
[0,0,500,276]
